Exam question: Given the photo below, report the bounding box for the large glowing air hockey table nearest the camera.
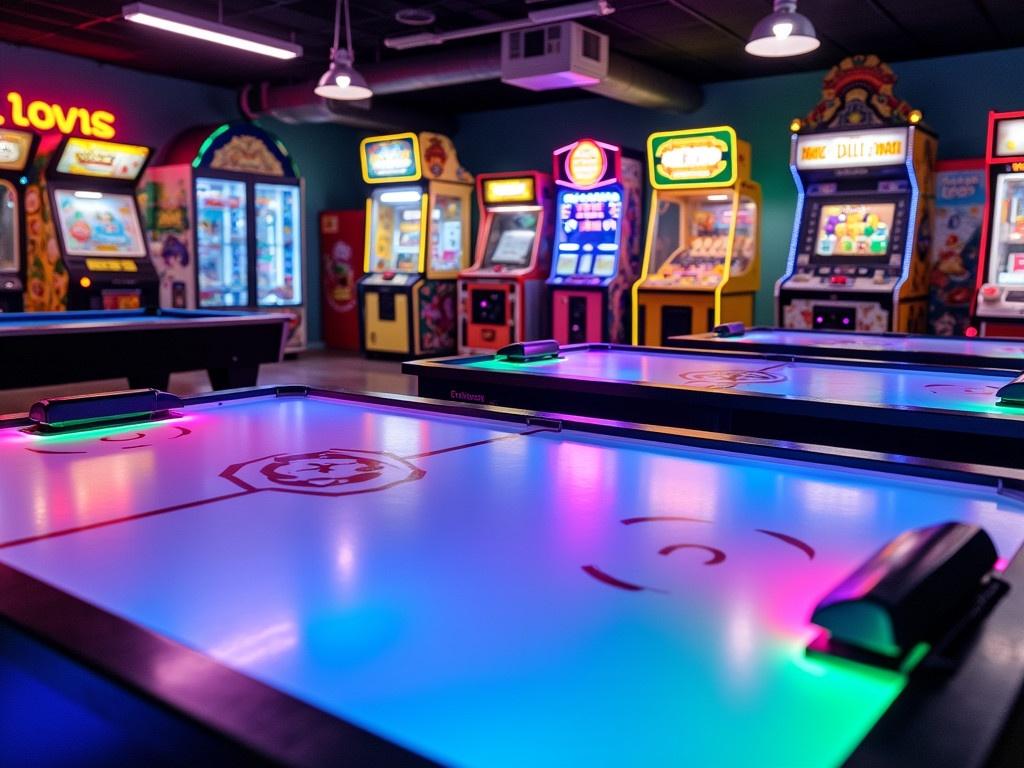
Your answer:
[0,387,1024,768]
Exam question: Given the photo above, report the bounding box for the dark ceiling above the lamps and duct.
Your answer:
[0,0,1024,110]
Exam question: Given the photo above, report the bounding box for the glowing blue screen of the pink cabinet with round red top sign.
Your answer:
[555,184,623,278]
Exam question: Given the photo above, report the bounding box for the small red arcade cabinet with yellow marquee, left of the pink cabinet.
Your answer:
[459,171,553,352]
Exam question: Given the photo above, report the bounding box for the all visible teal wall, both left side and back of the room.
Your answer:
[6,43,1024,341]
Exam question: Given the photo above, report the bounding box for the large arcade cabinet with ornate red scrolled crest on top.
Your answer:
[775,56,936,333]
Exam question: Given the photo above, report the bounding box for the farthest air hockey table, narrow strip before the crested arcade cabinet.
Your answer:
[669,323,1024,373]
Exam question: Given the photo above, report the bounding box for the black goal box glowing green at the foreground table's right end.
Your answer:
[807,522,1008,669]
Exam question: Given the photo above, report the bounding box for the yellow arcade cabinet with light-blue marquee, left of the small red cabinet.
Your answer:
[358,133,473,357]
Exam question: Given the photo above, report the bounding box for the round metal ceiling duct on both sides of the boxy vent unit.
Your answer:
[242,45,703,126]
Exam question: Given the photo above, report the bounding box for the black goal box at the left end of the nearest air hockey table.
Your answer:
[29,389,182,433]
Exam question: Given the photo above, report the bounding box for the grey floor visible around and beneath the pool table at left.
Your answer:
[0,350,416,414]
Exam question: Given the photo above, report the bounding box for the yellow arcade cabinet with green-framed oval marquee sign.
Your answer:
[633,126,761,345]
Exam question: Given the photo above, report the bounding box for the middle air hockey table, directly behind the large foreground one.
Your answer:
[402,341,1024,466]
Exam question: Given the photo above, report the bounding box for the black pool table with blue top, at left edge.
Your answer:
[0,308,289,389]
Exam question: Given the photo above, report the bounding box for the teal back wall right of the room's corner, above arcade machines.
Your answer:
[454,48,1024,324]
